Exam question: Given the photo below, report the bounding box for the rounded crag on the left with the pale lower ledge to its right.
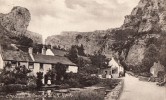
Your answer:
[0,6,42,43]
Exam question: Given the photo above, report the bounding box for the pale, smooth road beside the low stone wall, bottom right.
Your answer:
[120,74,166,100]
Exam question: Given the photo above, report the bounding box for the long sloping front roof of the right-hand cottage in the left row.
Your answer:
[33,54,76,66]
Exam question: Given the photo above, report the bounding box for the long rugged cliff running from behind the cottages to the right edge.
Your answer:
[46,0,166,65]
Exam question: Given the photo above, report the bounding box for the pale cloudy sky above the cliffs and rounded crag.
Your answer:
[0,0,139,38]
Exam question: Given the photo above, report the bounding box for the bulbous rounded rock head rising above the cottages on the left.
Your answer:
[0,7,31,34]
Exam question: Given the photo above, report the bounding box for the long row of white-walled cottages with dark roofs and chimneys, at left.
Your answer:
[0,45,78,83]
